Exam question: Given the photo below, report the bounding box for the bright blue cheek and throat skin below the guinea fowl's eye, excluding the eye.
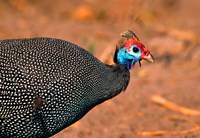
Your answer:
[117,48,140,70]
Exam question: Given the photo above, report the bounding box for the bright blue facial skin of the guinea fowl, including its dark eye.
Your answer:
[117,45,142,70]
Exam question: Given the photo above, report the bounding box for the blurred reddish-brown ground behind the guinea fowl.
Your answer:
[0,0,200,138]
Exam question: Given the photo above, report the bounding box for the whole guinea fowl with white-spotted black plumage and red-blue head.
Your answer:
[0,31,153,138]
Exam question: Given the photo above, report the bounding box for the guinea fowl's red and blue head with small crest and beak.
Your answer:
[114,30,154,69]
